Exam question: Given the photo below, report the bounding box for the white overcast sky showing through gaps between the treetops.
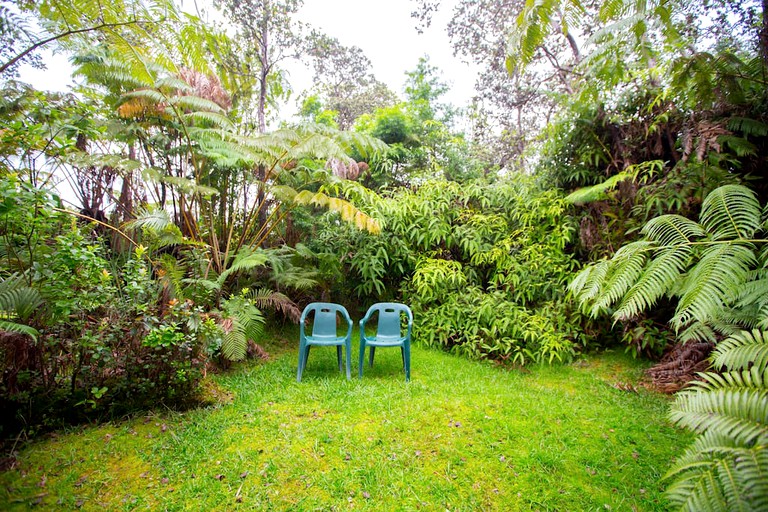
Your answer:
[21,0,475,110]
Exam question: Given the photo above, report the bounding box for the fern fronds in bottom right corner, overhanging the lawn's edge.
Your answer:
[666,330,768,511]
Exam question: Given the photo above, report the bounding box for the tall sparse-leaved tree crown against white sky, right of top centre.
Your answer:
[413,0,578,167]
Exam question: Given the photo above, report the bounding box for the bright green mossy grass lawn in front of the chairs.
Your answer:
[0,330,691,511]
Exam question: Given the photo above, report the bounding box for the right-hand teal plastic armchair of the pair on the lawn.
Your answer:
[358,302,413,381]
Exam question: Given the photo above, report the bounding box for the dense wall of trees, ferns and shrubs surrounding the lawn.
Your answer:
[0,0,768,509]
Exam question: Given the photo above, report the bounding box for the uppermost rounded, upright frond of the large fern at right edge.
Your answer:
[700,185,762,240]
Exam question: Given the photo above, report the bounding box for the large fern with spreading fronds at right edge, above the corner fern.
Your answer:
[569,185,768,341]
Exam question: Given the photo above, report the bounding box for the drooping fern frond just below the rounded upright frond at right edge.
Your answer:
[671,244,755,329]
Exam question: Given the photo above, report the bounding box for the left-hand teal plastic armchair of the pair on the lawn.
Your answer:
[296,302,352,382]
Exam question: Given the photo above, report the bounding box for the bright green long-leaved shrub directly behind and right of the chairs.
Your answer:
[307,176,592,364]
